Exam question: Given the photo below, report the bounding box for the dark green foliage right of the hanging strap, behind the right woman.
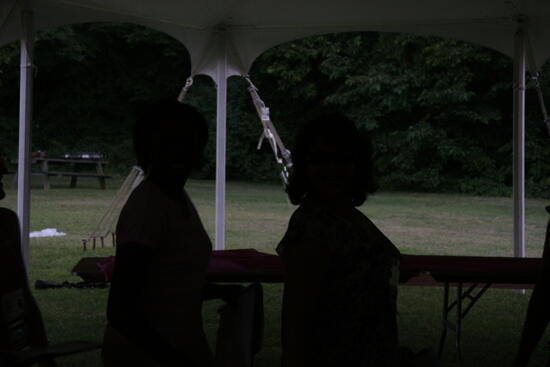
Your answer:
[256,33,550,196]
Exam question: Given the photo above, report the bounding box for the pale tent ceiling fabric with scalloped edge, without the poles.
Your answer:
[0,0,550,77]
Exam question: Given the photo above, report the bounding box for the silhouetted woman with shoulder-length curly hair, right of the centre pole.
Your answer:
[277,114,399,367]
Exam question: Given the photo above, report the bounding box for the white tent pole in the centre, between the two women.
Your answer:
[215,29,227,250]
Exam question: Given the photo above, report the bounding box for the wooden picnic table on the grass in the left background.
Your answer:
[12,157,111,190]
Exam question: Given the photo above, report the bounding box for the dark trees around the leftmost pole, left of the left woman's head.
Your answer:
[0,23,194,164]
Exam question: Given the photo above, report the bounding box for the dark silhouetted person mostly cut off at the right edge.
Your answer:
[514,206,550,367]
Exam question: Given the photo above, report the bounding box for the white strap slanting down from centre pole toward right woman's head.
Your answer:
[243,75,292,188]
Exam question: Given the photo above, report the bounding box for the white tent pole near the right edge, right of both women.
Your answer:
[513,22,525,257]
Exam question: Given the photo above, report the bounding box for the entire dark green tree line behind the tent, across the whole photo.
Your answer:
[0,24,550,196]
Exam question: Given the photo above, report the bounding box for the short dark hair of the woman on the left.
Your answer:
[133,99,208,173]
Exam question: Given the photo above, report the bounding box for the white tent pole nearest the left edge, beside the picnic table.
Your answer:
[17,2,34,268]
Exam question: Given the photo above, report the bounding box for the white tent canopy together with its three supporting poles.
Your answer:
[0,0,550,264]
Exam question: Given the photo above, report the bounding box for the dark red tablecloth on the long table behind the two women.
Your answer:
[72,249,542,284]
